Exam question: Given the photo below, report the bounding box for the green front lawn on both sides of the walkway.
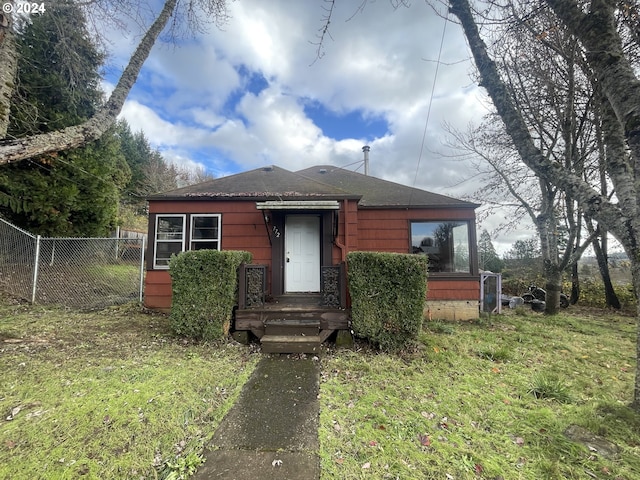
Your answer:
[0,298,640,480]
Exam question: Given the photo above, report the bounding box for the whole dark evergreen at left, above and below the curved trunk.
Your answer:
[0,2,130,236]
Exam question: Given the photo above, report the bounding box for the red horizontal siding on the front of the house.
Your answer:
[145,200,480,309]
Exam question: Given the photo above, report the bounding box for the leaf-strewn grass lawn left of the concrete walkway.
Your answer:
[0,299,256,479]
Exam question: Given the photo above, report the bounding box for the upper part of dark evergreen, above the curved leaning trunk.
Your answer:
[8,0,104,137]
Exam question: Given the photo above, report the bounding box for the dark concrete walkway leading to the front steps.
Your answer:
[193,355,320,480]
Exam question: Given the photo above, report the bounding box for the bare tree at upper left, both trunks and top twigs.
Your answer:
[0,0,227,165]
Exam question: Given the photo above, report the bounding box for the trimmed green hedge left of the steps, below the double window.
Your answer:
[169,250,253,340]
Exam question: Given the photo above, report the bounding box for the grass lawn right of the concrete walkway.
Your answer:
[320,308,640,480]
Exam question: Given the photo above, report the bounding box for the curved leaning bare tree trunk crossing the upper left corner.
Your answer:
[0,0,178,165]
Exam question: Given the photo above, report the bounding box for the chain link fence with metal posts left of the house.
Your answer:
[0,218,144,309]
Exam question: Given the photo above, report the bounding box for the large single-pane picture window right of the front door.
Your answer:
[411,221,471,273]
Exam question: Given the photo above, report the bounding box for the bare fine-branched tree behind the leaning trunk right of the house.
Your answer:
[444,5,598,314]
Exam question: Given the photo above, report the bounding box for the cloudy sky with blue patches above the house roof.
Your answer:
[100,0,533,251]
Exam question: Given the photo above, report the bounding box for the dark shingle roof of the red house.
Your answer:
[149,165,478,208]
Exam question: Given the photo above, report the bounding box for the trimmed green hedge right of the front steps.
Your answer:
[347,252,427,351]
